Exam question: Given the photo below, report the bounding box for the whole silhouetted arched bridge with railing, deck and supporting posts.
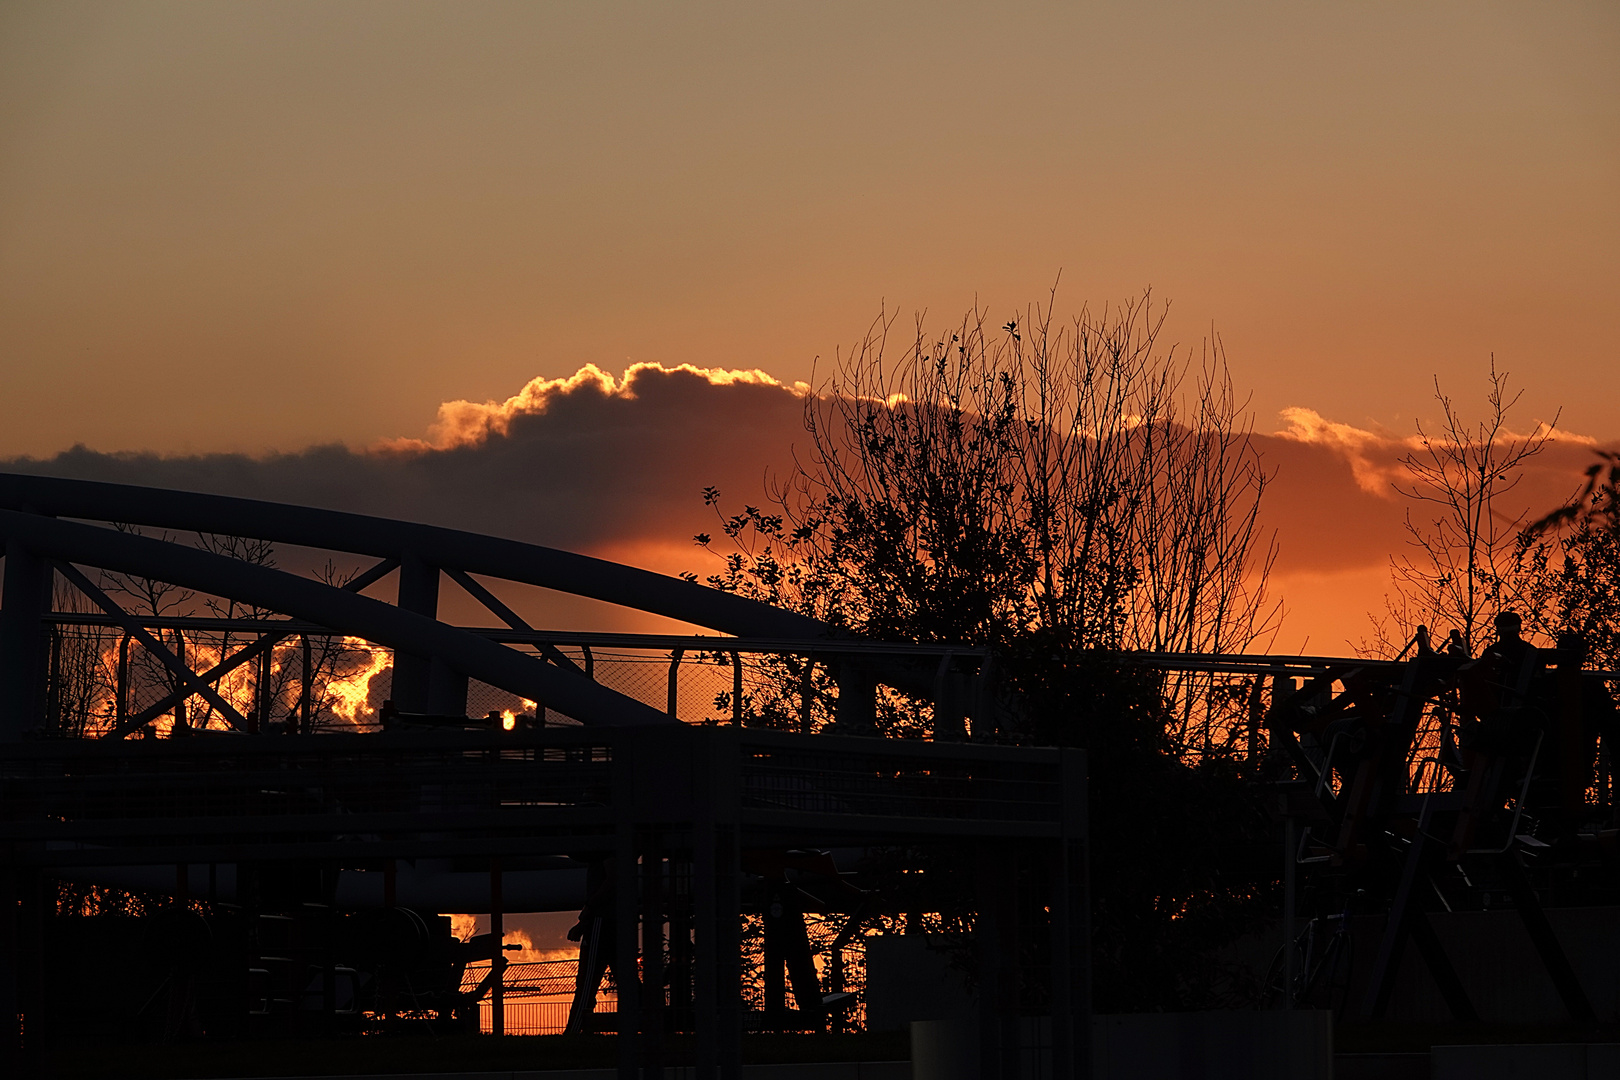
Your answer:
[0,474,1090,1078]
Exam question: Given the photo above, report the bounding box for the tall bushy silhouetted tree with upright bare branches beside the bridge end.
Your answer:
[697,293,1278,1009]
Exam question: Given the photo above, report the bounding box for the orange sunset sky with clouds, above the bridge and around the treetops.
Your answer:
[0,0,1620,653]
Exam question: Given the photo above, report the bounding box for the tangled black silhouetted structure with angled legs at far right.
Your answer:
[1262,625,1620,1028]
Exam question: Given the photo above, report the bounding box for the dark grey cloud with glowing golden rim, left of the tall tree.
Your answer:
[0,364,804,565]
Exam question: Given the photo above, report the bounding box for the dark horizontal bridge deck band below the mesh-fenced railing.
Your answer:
[0,727,1074,863]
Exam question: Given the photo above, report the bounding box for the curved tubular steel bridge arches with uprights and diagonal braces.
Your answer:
[0,473,831,740]
